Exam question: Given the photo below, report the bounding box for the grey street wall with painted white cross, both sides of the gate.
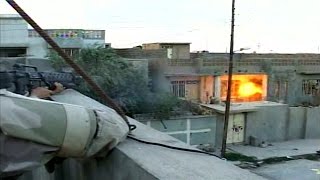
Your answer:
[138,104,320,147]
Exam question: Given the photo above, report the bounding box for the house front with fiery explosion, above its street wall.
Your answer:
[119,43,320,106]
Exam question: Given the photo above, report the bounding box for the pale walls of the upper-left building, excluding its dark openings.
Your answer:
[0,14,105,58]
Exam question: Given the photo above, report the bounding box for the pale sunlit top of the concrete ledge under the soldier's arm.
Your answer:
[111,120,263,180]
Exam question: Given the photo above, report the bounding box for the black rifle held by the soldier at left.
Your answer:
[0,64,80,95]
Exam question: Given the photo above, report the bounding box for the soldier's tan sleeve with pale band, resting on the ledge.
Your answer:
[0,89,129,177]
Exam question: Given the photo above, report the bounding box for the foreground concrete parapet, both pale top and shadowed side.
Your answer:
[18,119,263,180]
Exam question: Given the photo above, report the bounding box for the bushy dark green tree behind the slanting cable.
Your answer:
[48,47,179,116]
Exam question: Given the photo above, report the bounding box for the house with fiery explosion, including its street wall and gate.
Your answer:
[117,43,320,148]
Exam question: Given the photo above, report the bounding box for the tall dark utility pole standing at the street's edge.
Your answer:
[221,0,235,157]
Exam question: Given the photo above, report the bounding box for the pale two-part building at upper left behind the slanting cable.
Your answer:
[0,15,110,58]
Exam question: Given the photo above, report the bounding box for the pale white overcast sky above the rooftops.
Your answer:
[0,0,320,53]
